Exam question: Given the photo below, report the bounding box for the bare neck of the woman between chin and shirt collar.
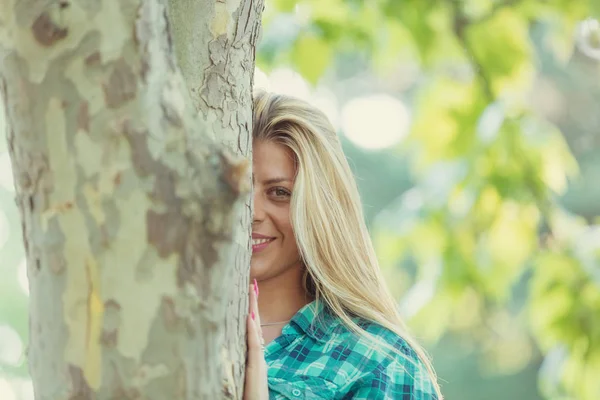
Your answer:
[258,265,312,326]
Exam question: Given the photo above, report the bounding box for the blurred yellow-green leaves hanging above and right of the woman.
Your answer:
[257,0,600,400]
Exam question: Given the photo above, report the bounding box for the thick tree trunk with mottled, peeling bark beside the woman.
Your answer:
[0,0,263,400]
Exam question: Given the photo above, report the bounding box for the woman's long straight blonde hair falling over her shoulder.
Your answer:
[253,91,442,400]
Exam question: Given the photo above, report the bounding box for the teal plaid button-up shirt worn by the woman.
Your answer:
[265,301,441,400]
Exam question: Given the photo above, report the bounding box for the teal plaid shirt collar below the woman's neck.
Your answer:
[282,300,338,342]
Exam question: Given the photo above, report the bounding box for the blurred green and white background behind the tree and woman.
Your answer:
[0,0,600,400]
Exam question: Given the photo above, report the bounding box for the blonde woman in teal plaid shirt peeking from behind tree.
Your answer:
[245,92,442,400]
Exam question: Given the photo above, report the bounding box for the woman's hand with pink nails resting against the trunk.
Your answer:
[244,279,269,400]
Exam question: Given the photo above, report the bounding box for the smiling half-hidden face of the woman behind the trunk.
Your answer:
[250,141,300,280]
